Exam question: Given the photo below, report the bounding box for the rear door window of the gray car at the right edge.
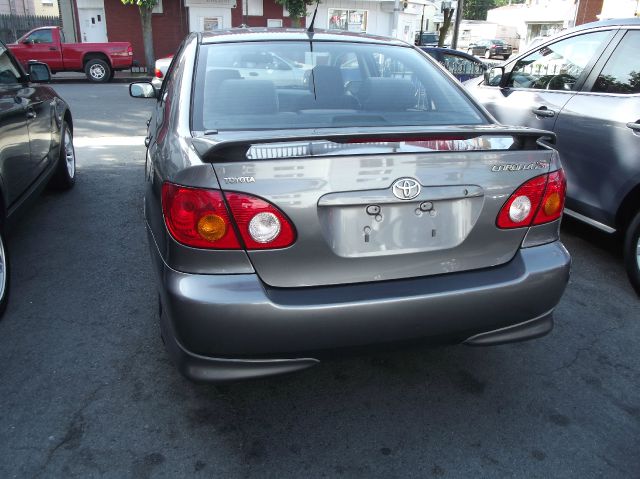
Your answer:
[592,30,640,95]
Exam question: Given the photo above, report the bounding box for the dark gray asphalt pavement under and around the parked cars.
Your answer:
[0,84,640,478]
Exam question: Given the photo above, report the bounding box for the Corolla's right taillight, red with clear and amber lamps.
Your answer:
[496,170,566,229]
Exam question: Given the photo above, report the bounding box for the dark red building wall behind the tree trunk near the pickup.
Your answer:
[104,0,189,66]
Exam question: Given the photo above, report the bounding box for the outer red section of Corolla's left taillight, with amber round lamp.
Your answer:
[162,183,240,249]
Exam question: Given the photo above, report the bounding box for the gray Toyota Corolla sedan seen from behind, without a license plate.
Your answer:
[130,29,570,381]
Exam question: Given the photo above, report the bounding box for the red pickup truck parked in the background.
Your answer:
[7,27,133,83]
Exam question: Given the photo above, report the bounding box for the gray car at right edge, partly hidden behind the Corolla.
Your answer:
[465,19,640,293]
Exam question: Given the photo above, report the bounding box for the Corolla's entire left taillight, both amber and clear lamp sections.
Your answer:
[162,182,296,250]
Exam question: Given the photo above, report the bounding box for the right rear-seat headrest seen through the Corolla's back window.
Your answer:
[360,78,416,111]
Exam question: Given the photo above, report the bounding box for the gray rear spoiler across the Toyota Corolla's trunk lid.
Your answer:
[192,125,556,162]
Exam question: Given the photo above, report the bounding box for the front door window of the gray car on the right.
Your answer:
[507,31,611,91]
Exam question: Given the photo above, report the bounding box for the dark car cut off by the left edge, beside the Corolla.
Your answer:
[0,43,75,315]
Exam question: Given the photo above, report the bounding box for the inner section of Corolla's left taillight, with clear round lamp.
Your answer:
[225,192,296,249]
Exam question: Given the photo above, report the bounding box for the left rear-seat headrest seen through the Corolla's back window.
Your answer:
[214,80,278,115]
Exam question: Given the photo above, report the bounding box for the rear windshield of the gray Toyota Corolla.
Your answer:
[192,41,487,131]
